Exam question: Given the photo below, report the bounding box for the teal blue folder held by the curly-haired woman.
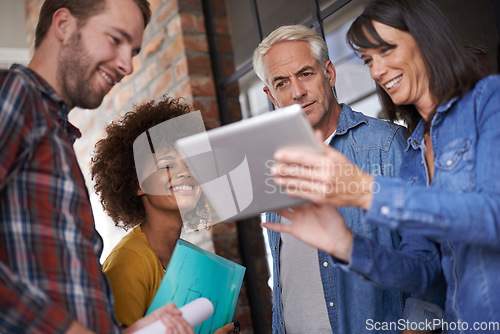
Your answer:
[146,239,245,334]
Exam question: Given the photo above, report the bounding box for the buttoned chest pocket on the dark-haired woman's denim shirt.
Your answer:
[434,138,476,192]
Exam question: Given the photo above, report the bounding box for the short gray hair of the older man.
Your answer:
[253,25,328,85]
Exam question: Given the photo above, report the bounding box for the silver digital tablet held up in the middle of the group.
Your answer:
[176,105,321,221]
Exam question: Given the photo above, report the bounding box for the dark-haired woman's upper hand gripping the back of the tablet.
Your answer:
[271,130,374,210]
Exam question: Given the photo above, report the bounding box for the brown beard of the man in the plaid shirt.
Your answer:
[57,32,105,109]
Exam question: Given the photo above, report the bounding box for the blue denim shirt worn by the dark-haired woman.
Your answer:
[366,75,500,333]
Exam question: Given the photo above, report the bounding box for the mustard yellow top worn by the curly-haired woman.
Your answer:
[103,225,165,327]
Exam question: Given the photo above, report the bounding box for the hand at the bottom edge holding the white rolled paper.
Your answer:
[123,303,194,334]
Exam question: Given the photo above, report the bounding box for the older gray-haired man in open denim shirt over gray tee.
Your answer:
[253,25,437,334]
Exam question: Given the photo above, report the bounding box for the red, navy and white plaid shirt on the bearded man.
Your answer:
[0,65,120,333]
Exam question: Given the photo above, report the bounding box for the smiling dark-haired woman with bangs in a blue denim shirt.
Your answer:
[264,0,500,333]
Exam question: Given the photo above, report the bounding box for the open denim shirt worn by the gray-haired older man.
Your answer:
[266,104,422,334]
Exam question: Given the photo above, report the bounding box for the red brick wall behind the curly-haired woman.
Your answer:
[24,0,271,333]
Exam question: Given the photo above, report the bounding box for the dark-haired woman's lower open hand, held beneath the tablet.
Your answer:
[262,204,353,263]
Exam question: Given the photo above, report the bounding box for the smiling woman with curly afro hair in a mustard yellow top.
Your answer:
[91,97,233,334]
